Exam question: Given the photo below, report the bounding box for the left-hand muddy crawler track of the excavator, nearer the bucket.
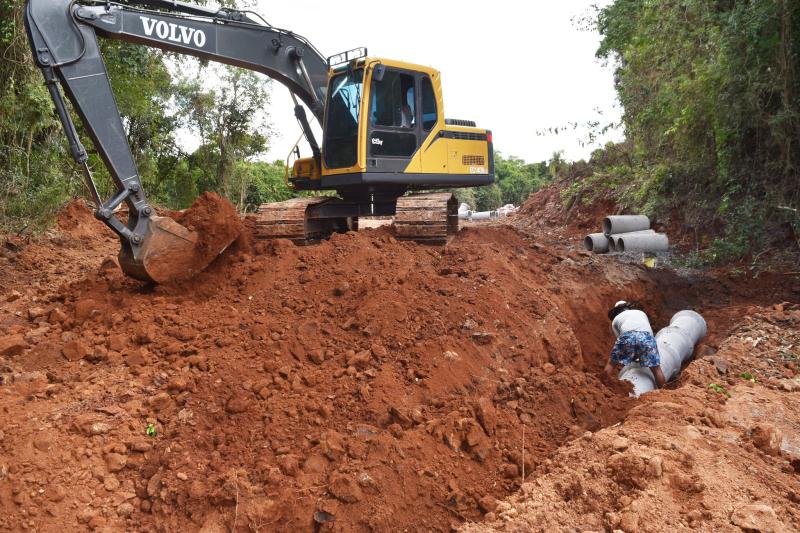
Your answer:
[253,197,356,245]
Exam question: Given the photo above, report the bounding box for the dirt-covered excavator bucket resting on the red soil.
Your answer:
[119,216,238,283]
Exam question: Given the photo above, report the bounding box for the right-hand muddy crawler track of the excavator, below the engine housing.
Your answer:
[394,192,458,245]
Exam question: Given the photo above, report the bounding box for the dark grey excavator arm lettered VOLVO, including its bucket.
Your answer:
[25,0,328,282]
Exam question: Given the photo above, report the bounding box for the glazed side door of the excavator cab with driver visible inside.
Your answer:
[366,66,422,173]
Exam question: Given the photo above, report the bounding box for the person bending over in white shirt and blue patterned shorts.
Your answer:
[605,300,667,388]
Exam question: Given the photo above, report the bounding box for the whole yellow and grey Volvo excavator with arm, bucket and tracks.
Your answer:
[24,0,494,282]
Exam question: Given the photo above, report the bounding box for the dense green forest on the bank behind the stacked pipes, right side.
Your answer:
[569,0,800,262]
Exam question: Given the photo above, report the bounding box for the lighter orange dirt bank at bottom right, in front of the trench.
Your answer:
[462,304,800,533]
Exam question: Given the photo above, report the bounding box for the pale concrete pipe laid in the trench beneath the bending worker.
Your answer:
[619,311,708,398]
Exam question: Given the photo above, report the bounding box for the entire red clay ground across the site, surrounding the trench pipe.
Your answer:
[0,197,800,531]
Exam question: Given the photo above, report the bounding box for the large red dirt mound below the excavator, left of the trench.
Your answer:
[0,215,646,531]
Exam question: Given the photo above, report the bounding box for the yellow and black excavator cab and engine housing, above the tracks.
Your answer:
[289,53,494,197]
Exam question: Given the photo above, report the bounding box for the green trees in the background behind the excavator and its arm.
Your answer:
[0,0,550,231]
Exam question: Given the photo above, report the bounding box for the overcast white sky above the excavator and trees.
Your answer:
[178,0,621,162]
